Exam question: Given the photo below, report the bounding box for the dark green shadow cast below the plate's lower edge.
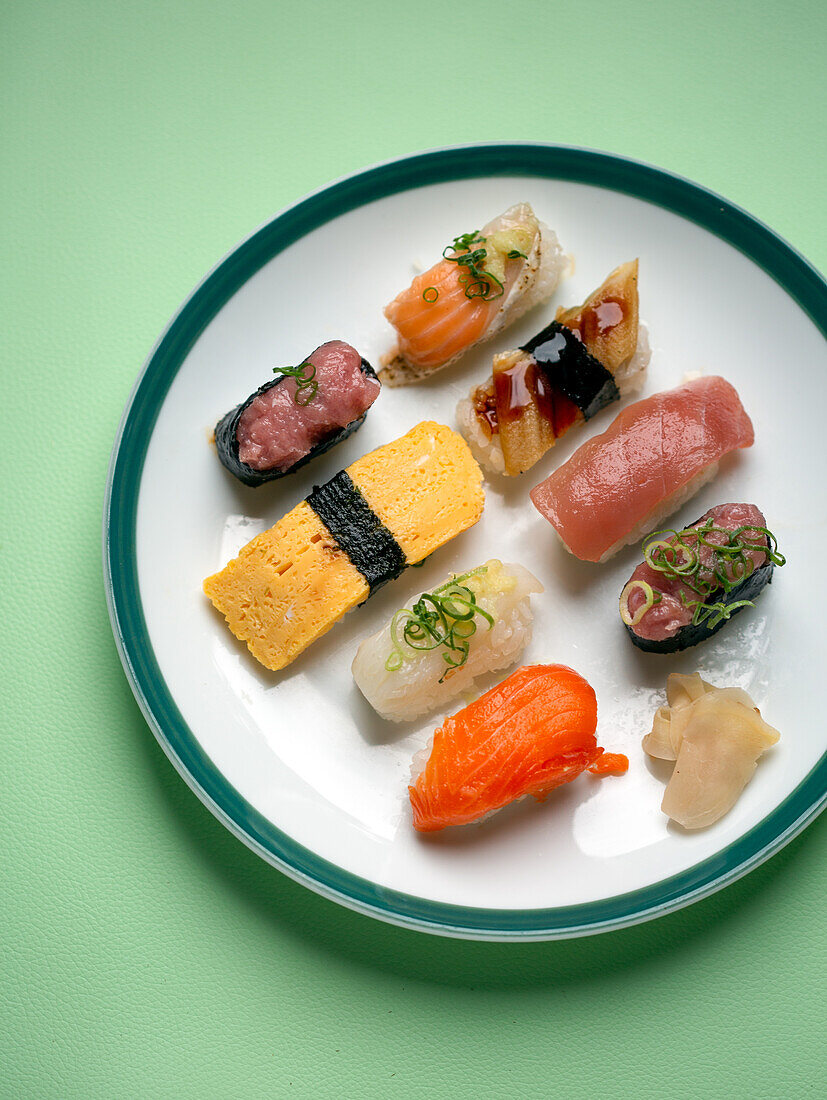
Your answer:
[124,682,827,992]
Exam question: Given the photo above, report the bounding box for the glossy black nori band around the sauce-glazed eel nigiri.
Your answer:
[521,321,620,420]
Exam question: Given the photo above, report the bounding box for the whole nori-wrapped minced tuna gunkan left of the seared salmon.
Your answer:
[216,340,381,485]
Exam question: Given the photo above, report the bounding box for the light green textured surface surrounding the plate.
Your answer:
[0,0,827,1098]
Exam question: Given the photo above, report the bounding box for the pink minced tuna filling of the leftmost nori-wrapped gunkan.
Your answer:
[235,340,382,470]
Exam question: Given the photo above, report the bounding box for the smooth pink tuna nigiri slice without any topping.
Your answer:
[531,375,754,561]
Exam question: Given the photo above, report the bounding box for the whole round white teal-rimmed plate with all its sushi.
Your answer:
[104,143,827,941]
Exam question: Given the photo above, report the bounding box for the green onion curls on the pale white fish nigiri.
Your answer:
[385,565,494,683]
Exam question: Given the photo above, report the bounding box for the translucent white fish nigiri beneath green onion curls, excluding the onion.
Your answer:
[352,559,543,722]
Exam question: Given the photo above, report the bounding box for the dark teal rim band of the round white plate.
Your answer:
[103,142,827,941]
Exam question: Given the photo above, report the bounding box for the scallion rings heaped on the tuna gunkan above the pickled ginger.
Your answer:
[633,517,786,630]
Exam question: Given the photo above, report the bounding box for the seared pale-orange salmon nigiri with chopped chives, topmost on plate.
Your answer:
[379,202,566,386]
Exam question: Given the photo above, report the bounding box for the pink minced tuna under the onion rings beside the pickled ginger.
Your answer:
[628,504,767,641]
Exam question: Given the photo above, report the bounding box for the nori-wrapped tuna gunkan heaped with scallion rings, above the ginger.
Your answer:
[620,504,785,653]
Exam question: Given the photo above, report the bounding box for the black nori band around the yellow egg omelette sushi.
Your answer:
[307,470,408,593]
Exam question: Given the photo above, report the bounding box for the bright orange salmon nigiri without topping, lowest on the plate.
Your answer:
[408,664,629,833]
